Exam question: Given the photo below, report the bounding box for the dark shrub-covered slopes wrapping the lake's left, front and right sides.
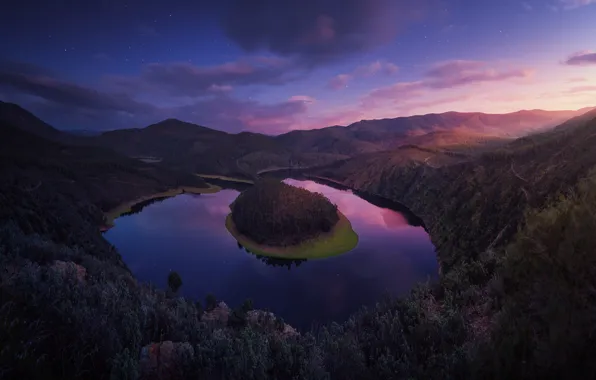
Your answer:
[0,102,596,380]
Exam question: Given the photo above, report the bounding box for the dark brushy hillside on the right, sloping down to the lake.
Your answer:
[312,107,596,379]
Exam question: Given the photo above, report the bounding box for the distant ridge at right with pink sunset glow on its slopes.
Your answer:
[277,110,583,155]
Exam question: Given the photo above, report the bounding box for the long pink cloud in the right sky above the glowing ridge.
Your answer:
[363,60,533,106]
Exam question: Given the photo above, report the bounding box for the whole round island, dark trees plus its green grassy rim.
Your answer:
[226,179,358,258]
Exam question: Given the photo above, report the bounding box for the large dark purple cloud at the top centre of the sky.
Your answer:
[221,0,436,64]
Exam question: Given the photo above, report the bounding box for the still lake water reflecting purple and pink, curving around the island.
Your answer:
[105,179,438,328]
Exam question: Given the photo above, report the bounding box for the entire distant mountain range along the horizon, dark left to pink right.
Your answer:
[0,103,592,177]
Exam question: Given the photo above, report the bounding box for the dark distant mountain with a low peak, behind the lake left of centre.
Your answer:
[95,119,346,178]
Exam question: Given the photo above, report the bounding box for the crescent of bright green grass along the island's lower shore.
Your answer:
[226,211,358,259]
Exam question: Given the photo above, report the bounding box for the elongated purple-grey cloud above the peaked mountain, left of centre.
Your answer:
[108,57,301,97]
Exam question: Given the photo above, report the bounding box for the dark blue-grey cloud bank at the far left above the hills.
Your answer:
[0,60,153,113]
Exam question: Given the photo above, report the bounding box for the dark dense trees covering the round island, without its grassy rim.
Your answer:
[230,179,339,247]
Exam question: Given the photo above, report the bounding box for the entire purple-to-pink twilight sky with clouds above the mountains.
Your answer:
[0,0,596,134]
